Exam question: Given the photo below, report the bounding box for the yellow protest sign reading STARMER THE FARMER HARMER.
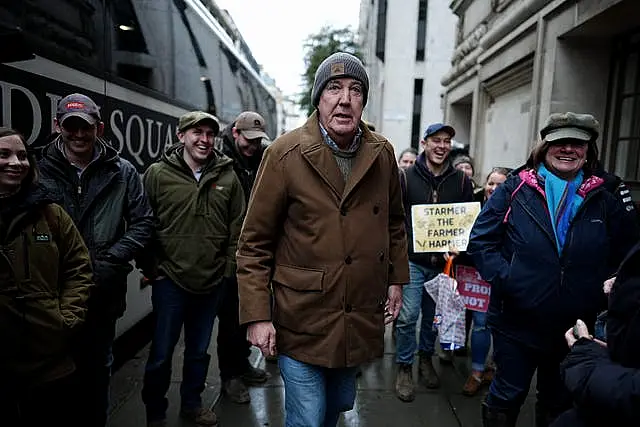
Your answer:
[411,202,480,252]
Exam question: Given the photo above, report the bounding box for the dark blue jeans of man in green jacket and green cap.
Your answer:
[142,278,225,421]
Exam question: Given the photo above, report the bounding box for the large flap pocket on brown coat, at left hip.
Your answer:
[272,265,328,335]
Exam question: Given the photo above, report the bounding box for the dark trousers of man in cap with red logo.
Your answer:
[72,307,116,427]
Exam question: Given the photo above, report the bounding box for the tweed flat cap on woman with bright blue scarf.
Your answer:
[540,112,600,142]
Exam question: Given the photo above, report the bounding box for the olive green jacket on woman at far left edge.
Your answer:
[0,188,93,389]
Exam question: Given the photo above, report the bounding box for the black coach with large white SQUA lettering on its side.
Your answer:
[0,0,277,342]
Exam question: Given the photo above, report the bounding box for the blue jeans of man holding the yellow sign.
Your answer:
[396,262,439,364]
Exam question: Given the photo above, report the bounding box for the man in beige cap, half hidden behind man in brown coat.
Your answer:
[217,111,269,403]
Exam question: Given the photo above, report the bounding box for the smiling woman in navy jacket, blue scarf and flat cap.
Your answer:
[468,113,638,427]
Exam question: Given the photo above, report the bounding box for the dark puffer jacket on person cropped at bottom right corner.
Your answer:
[552,245,640,427]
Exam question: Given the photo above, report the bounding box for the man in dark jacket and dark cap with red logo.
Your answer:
[39,93,153,427]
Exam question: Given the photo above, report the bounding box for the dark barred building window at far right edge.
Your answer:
[609,33,640,182]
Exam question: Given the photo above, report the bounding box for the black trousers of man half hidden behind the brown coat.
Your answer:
[217,276,251,381]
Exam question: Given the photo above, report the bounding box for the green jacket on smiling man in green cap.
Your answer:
[143,143,245,293]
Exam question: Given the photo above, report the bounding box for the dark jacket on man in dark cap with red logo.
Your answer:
[39,138,153,318]
